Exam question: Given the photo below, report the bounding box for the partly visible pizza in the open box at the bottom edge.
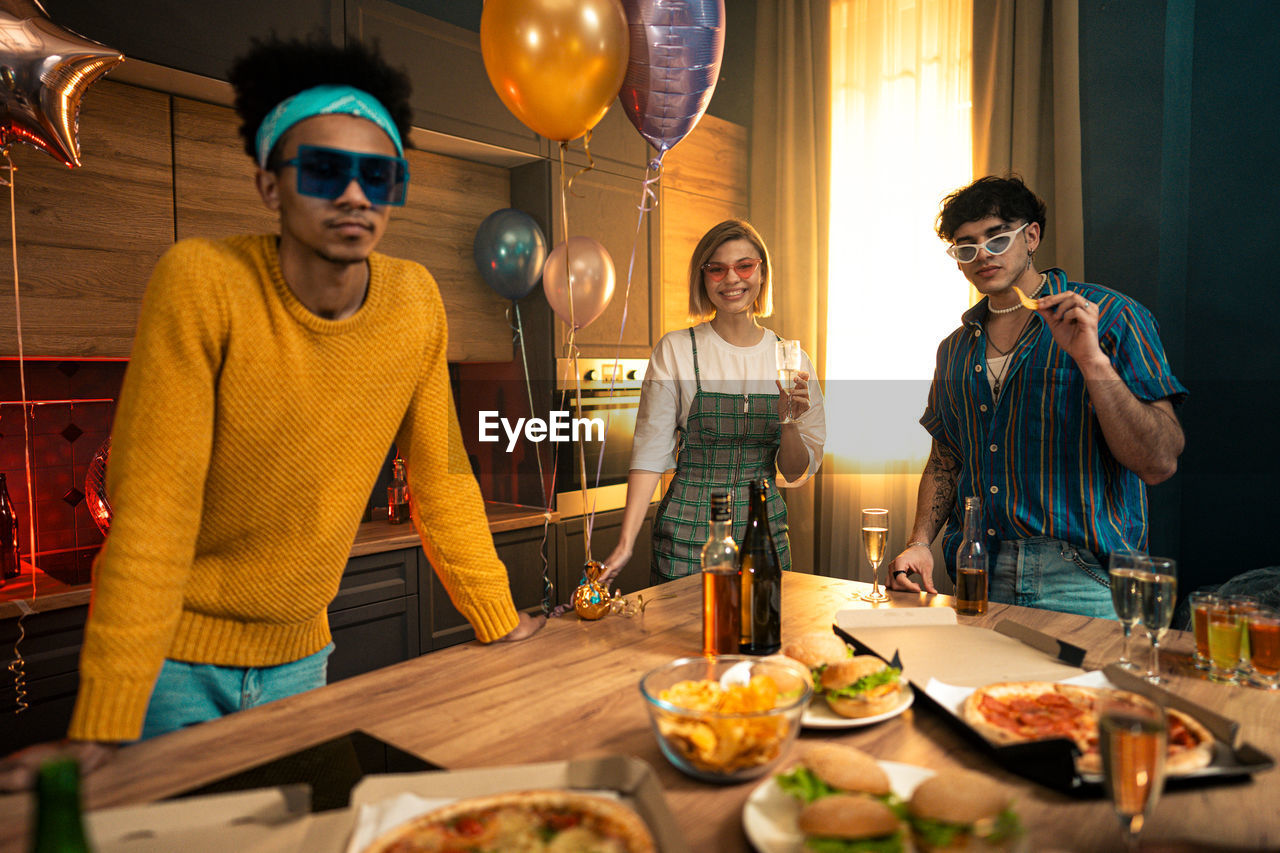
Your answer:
[364,790,657,853]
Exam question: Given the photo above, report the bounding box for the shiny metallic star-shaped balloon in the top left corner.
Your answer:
[0,0,124,168]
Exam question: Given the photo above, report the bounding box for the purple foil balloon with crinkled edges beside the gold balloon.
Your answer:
[618,0,724,159]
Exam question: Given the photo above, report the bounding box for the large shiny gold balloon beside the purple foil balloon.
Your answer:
[480,0,630,142]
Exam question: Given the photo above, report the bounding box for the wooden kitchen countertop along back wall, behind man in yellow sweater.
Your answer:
[0,501,559,619]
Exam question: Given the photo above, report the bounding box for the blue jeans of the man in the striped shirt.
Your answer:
[988,537,1115,619]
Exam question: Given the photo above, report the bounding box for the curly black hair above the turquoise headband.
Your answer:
[228,35,413,160]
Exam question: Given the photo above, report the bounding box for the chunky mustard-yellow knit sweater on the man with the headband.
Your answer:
[69,236,517,740]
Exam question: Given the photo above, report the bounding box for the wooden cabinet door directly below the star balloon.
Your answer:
[0,81,173,359]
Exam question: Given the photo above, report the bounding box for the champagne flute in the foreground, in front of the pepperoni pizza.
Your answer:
[1098,690,1169,850]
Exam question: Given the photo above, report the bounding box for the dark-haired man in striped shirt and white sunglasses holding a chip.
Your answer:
[890,177,1187,617]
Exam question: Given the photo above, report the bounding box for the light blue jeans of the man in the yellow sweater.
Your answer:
[142,643,333,740]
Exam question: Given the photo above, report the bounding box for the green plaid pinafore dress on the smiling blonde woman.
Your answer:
[650,329,791,583]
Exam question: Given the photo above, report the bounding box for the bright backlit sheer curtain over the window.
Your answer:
[819,0,973,580]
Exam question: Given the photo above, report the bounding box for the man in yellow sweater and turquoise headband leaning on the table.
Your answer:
[0,41,543,785]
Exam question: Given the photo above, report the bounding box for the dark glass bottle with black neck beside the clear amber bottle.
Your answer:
[739,479,782,654]
